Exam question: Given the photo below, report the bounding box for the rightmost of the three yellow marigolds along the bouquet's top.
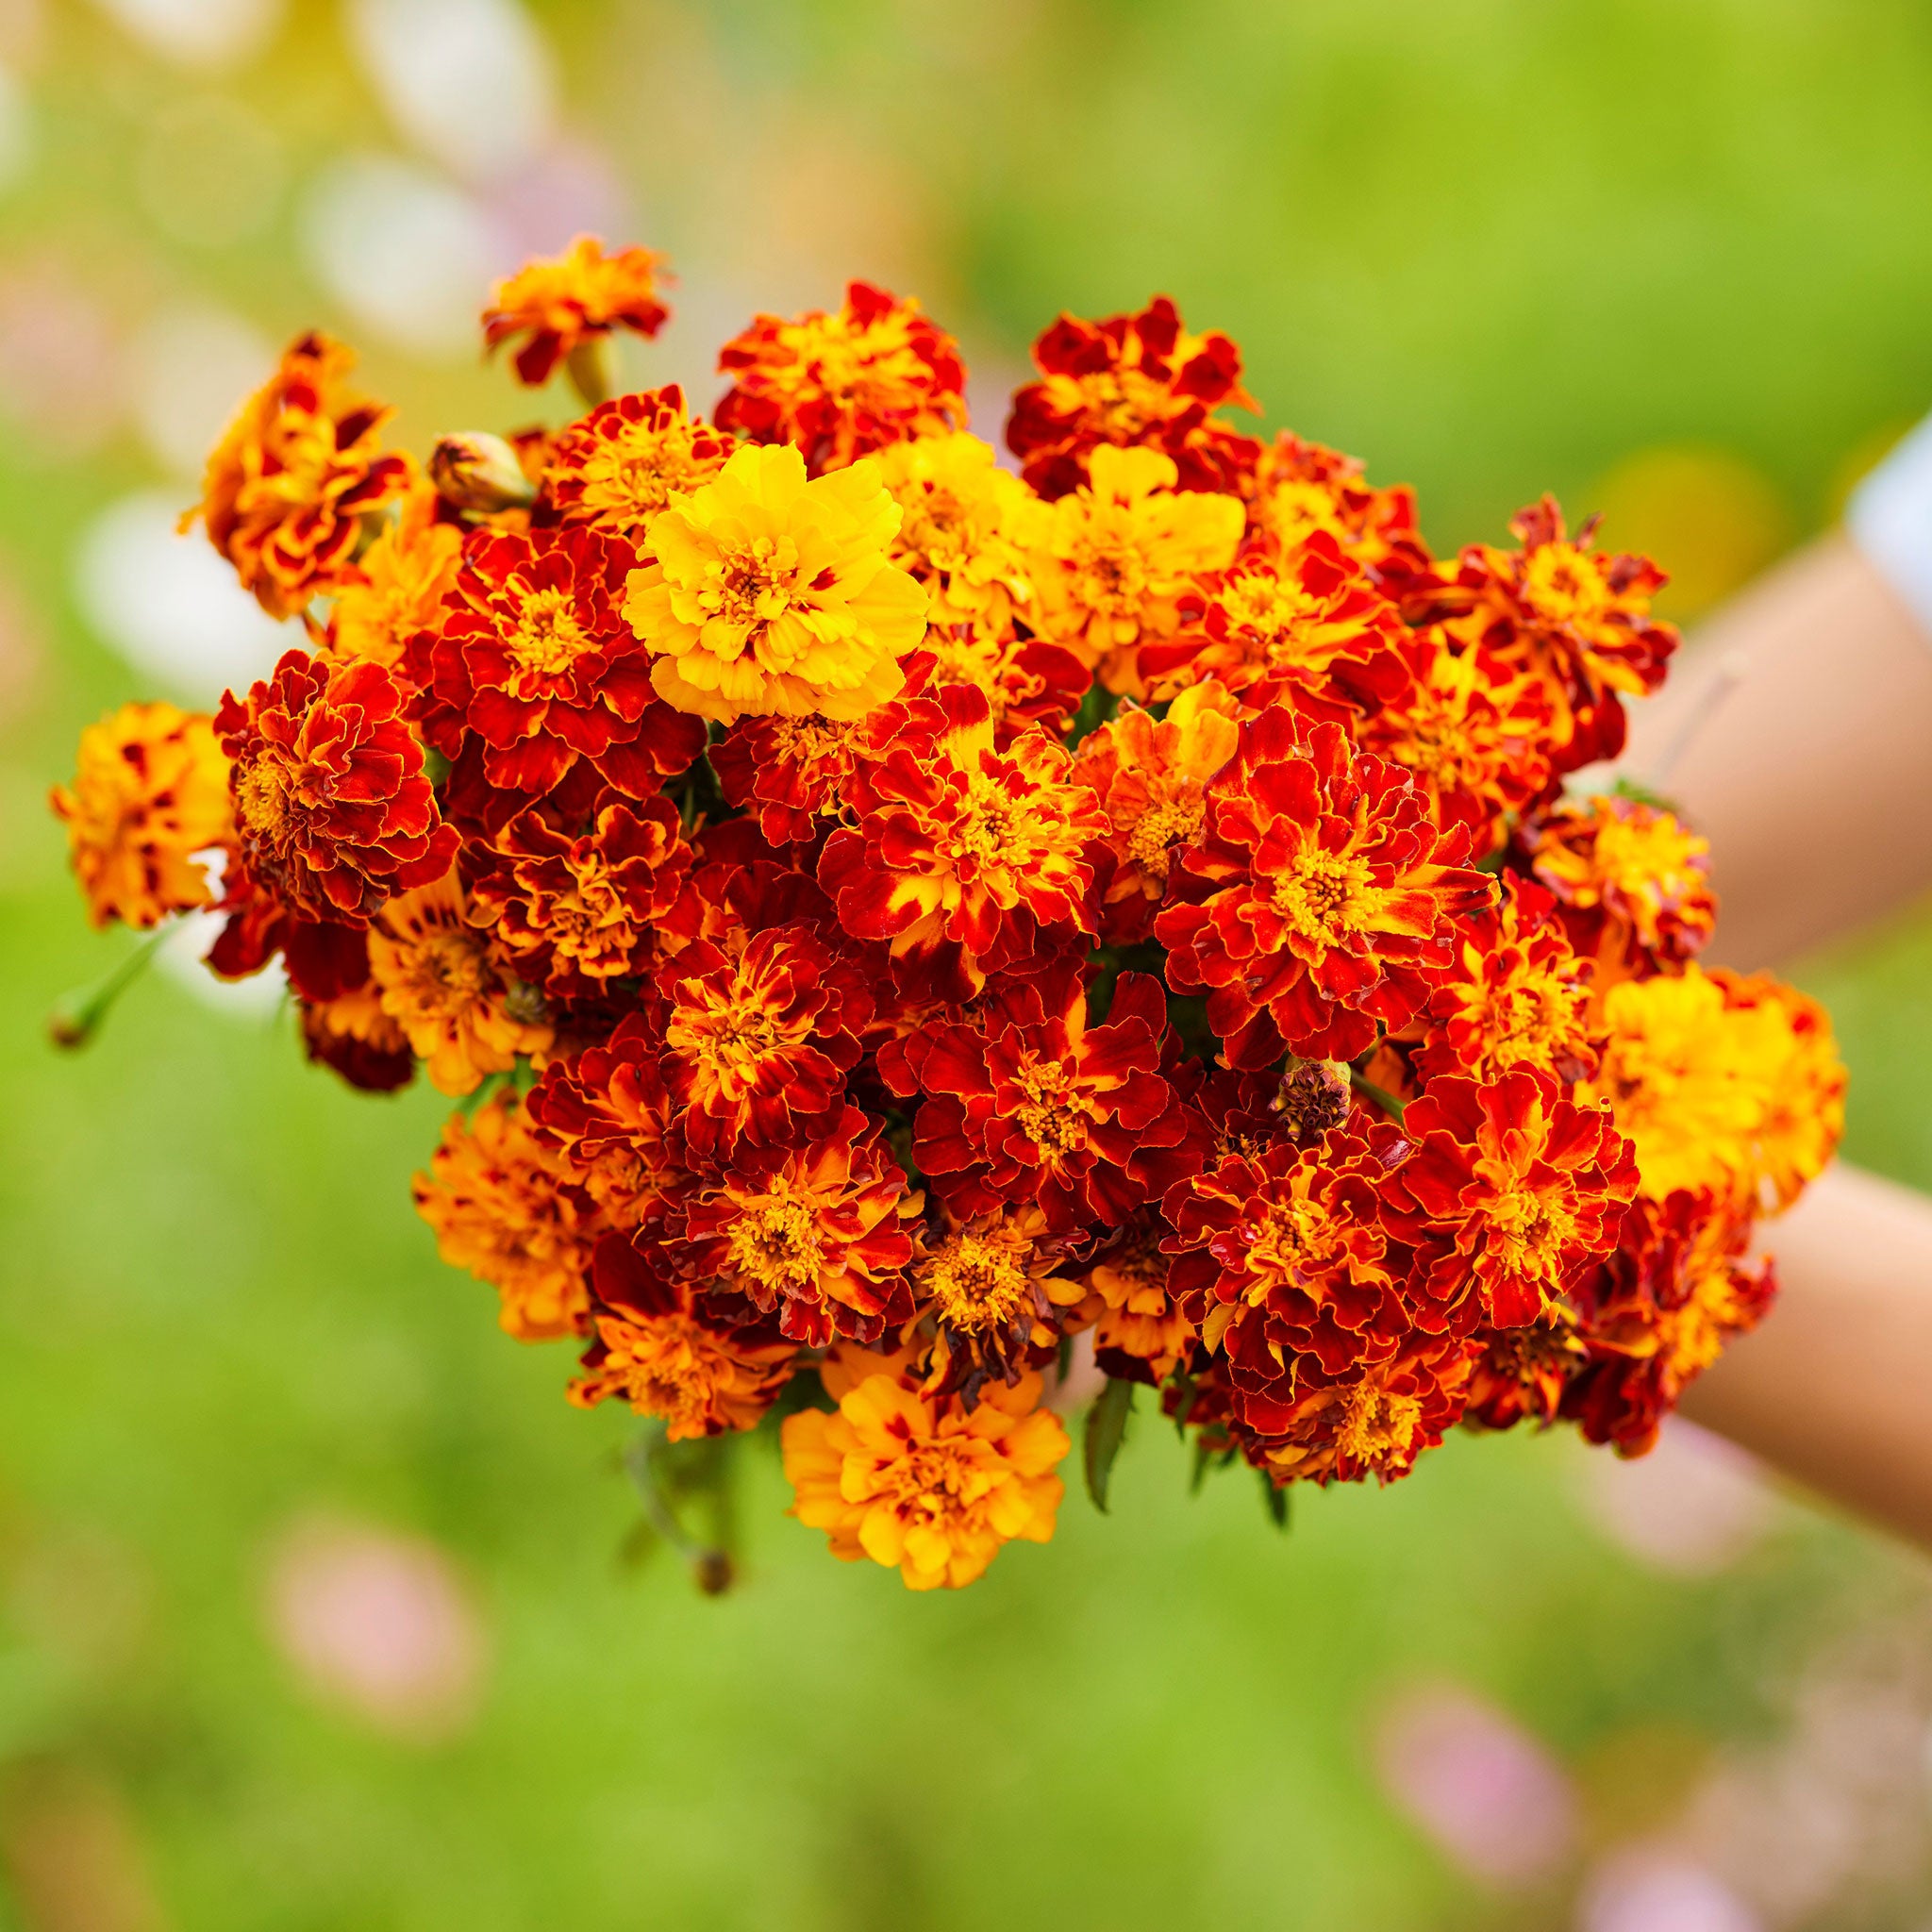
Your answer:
[1032,444,1246,695]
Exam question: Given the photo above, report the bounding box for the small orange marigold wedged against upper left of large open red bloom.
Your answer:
[1071,682,1241,944]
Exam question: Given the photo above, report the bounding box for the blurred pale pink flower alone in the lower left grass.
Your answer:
[267,1519,487,1740]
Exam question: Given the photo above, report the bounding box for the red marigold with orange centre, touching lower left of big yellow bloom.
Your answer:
[406,527,706,798]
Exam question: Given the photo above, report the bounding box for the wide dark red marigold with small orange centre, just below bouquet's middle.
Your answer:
[879,972,1186,1233]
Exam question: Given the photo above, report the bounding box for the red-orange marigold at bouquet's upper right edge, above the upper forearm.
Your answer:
[1451,496,1677,771]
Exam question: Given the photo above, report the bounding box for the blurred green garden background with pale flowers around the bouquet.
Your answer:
[0,0,1932,1932]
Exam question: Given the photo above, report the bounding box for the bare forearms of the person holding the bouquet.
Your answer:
[1623,535,1932,1549]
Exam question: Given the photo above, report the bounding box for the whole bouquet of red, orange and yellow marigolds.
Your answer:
[54,240,1845,1591]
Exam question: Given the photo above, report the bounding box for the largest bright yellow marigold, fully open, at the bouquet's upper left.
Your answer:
[625,444,925,724]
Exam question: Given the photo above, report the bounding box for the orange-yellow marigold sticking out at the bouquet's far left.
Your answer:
[48,706,234,927]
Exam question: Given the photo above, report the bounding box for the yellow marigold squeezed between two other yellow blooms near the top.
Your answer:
[874,431,1045,638]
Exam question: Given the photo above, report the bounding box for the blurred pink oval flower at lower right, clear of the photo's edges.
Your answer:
[1375,1685,1576,1886]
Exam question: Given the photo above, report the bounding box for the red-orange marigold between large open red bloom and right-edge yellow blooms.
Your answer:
[1416,874,1598,1080]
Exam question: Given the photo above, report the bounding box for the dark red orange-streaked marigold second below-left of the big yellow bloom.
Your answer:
[464,794,691,997]
